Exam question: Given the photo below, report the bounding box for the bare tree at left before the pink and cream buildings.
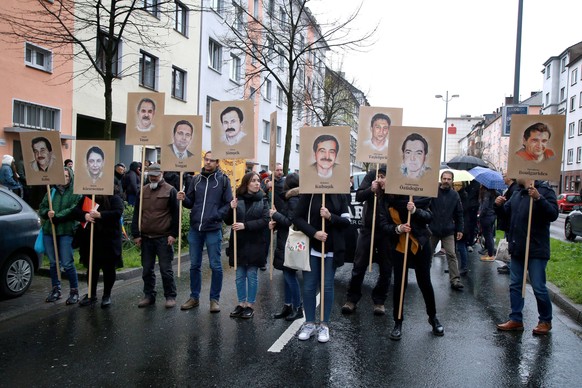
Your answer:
[0,0,198,139]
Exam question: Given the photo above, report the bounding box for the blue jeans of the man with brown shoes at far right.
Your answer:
[509,258,552,322]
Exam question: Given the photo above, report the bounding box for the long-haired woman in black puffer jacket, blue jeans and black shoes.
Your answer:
[225,172,269,319]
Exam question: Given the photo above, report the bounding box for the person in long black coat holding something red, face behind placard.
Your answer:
[75,195,123,308]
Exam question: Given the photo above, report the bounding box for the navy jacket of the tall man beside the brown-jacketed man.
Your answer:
[183,170,232,232]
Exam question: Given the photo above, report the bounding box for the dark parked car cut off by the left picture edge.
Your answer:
[0,186,41,298]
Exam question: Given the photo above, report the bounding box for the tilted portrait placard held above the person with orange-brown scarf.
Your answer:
[386,126,443,197]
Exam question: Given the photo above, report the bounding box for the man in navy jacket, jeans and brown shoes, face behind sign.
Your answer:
[495,178,559,335]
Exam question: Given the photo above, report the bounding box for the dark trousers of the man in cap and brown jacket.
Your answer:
[141,237,176,299]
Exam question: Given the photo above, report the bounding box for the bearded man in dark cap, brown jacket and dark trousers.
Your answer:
[131,163,180,308]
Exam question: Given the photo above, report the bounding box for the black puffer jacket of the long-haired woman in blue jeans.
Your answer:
[225,190,270,267]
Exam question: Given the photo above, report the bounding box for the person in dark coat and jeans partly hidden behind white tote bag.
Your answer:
[269,173,303,321]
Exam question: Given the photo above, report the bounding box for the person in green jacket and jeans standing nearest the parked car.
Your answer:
[38,167,81,305]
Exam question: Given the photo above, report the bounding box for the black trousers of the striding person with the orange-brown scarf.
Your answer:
[392,241,436,321]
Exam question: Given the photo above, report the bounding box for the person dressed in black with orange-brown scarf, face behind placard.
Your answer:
[378,194,445,341]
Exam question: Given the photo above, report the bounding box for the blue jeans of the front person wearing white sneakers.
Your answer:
[303,255,335,323]
